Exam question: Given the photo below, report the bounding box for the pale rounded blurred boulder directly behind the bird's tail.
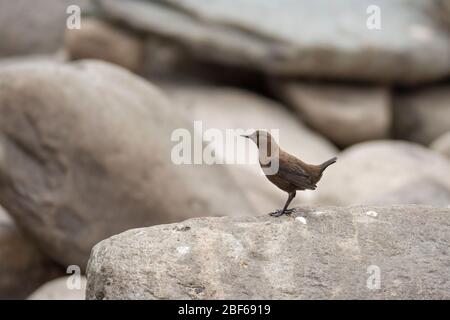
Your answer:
[314,141,450,206]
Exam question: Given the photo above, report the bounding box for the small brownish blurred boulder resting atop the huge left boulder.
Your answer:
[64,18,144,71]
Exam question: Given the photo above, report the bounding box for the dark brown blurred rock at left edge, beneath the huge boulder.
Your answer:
[0,207,63,300]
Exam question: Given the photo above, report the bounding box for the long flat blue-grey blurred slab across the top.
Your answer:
[98,0,450,83]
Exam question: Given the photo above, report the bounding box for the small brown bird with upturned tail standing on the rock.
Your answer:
[243,130,337,217]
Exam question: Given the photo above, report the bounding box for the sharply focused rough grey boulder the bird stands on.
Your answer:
[86,206,450,299]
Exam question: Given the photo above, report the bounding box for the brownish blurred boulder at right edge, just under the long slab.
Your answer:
[393,85,450,145]
